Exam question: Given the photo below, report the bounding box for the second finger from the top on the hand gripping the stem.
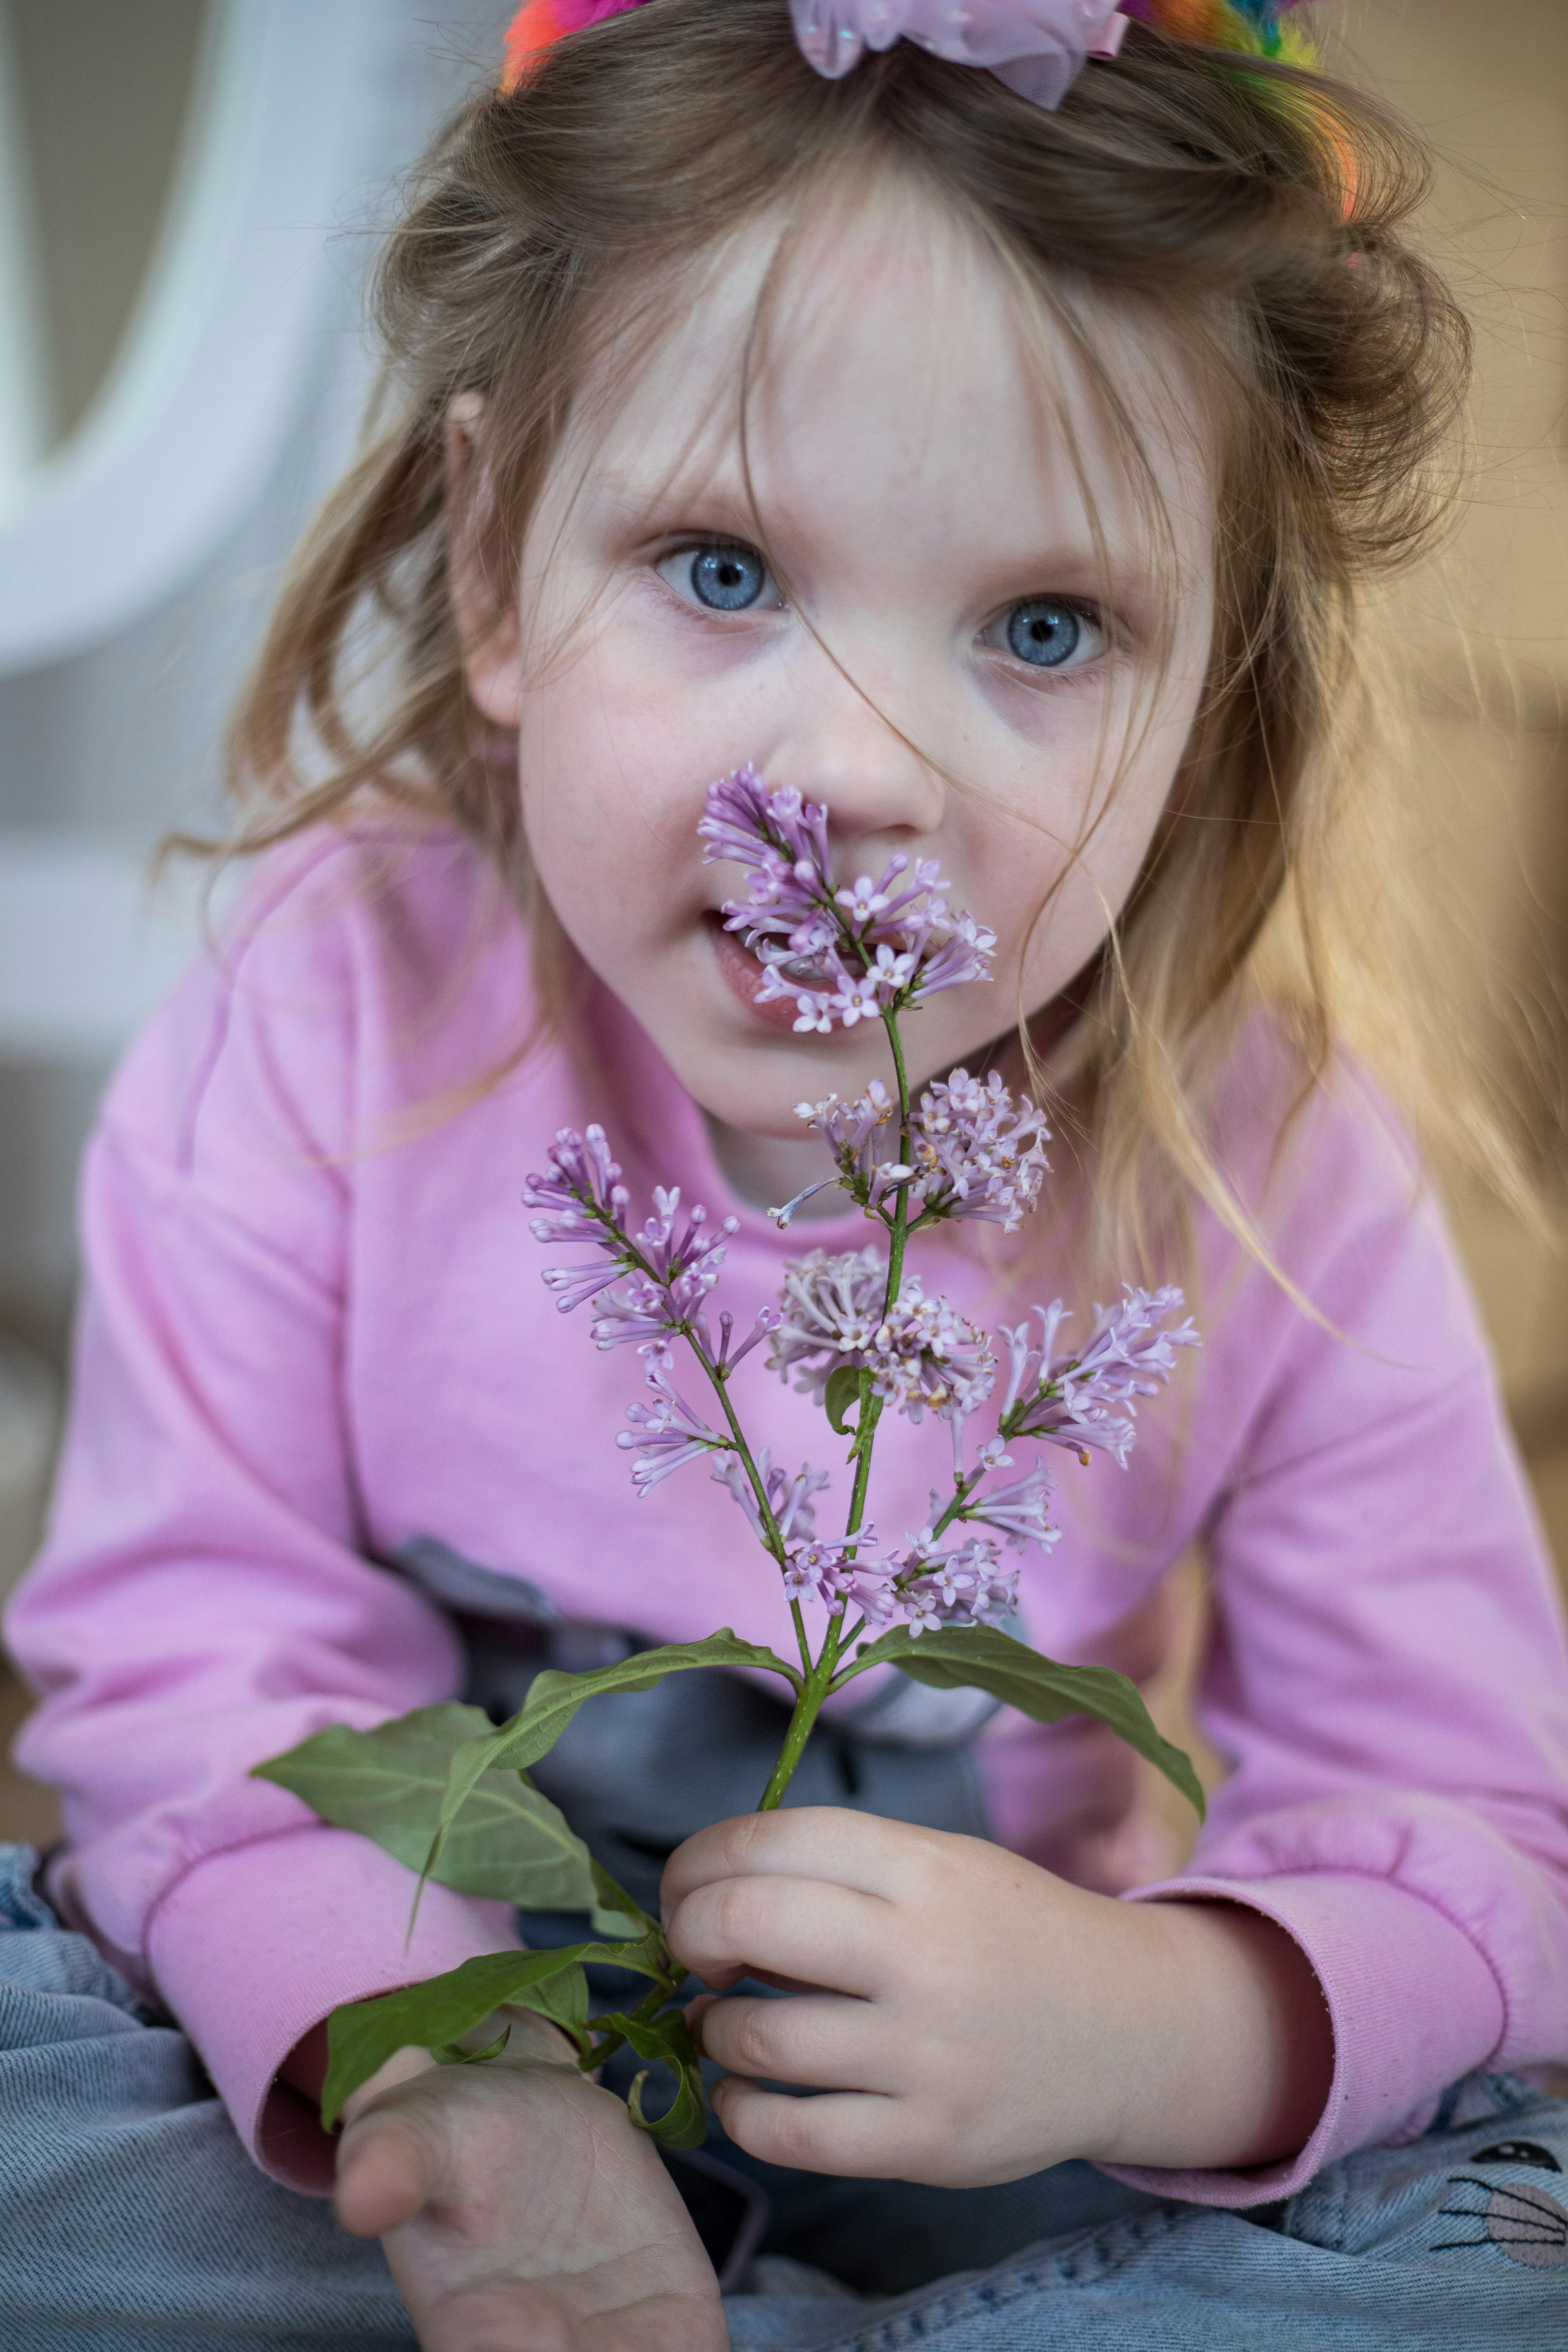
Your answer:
[665,1877,898,1997]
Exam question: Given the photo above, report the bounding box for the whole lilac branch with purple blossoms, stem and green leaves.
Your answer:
[288,769,1201,2147]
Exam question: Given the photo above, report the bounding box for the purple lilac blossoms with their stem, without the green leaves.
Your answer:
[527,767,1197,1809]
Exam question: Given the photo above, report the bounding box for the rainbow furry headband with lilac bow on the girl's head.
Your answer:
[501,0,1316,108]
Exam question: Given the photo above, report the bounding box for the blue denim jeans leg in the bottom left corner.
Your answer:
[0,1846,416,2352]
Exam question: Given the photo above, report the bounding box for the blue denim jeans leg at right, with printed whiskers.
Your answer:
[729,2074,1568,2352]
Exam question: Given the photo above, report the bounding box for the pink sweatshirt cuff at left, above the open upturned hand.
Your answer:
[146,1827,517,2197]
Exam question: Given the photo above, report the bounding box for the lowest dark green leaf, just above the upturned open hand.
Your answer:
[322,1931,670,2131]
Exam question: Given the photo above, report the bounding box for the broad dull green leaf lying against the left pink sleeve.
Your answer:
[254,1705,606,1933]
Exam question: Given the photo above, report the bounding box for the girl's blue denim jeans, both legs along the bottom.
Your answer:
[0,1846,1568,2352]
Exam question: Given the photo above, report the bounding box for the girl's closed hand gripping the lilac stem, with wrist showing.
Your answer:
[663,1806,1333,2188]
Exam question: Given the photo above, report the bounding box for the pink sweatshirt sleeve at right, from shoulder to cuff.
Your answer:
[1105,1082,1568,2206]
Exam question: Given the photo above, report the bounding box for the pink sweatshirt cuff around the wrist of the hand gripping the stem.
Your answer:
[1102,1872,1507,2206]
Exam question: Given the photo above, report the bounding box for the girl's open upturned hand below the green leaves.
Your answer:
[336,2011,729,2352]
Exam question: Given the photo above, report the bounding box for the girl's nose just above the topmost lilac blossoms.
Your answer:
[769,649,947,847]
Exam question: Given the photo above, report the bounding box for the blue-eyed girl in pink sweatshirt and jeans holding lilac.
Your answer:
[0,0,1568,2352]
